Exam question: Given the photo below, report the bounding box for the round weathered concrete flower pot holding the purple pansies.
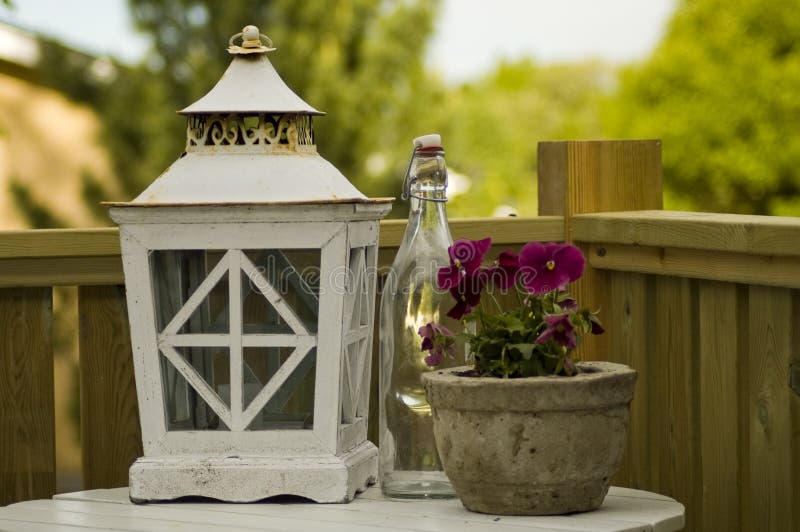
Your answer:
[423,362,636,515]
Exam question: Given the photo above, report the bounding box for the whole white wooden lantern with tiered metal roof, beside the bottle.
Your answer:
[109,26,392,502]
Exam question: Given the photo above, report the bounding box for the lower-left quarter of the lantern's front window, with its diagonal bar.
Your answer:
[161,347,230,430]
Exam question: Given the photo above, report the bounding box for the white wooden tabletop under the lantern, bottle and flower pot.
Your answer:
[0,487,684,532]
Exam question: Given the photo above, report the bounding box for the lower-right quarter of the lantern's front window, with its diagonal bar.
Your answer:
[242,347,317,430]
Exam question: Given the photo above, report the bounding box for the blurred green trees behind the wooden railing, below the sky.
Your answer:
[25,0,800,219]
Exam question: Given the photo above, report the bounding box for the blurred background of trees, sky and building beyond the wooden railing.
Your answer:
[0,0,800,490]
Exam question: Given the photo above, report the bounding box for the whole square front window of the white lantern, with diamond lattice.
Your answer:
[151,249,320,431]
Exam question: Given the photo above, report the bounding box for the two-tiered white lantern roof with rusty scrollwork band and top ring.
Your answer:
[107,26,391,207]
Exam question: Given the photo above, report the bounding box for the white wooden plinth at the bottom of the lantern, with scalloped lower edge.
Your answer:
[129,442,378,503]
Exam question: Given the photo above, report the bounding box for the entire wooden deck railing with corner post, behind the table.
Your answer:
[0,141,800,531]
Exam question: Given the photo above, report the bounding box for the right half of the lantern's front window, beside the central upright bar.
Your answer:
[241,249,320,430]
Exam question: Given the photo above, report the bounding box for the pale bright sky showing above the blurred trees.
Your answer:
[0,0,677,83]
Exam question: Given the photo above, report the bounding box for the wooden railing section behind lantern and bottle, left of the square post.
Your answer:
[0,216,564,505]
